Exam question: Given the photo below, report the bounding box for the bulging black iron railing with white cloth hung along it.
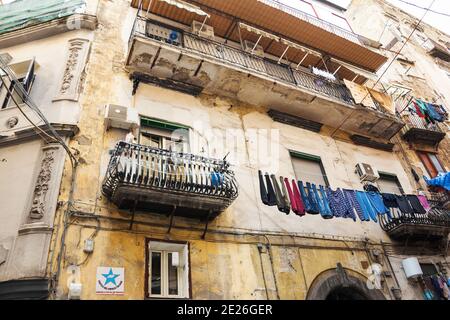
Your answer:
[103,141,238,203]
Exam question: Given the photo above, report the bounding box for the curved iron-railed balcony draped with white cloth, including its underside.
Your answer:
[102,141,238,220]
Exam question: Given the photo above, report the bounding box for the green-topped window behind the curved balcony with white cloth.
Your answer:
[139,118,189,153]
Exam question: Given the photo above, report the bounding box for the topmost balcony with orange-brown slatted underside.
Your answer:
[131,0,387,72]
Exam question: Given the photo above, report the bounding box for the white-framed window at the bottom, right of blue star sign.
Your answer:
[147,241,189,299]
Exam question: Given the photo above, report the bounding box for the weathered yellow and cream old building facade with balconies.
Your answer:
[0,0,450,300]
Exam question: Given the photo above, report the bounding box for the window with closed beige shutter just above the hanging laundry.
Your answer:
[291,151,329,187]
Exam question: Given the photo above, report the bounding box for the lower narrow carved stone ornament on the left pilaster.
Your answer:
[30,149,55,219]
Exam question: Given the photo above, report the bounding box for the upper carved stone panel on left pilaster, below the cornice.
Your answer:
[53,38,89,101]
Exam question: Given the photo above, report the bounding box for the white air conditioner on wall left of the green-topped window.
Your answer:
[105,104,139,130]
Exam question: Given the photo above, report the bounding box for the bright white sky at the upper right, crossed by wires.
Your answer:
[330,0,450,35]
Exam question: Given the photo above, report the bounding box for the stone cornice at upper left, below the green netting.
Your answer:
[0,14,97,48]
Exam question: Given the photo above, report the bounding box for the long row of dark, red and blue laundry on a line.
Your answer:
[258,170,431,222]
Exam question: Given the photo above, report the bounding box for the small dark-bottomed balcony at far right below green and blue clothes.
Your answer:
[402,113,445,147]
